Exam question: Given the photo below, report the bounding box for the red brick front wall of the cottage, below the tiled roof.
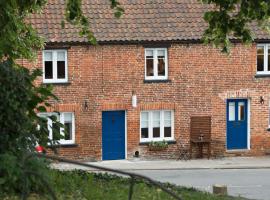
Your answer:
[20,44,270,160]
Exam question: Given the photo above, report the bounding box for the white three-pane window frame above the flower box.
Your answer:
[140,110,174,142]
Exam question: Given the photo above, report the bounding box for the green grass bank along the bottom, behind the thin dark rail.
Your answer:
[4,170,248,200]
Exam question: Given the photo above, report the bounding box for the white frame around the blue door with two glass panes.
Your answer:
[225,98,250,151]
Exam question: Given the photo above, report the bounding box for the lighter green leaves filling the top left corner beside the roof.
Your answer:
[0,0,46,59]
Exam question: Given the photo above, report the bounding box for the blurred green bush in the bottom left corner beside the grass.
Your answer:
[0,152,49,199]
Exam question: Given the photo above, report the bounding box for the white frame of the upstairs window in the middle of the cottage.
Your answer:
[144,48,168,80]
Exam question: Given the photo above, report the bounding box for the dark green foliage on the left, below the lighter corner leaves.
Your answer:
[0,59,63,197]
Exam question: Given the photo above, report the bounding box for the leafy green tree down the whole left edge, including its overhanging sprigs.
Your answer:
[0,0,122,199]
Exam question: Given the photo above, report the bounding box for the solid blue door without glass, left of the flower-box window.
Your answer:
[102,111,125,160]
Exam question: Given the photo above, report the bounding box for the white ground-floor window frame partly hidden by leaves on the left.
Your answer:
[38,112,75,144]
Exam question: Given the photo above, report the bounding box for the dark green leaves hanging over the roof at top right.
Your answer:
[202,0,270,52]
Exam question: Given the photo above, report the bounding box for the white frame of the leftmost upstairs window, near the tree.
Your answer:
[42,49,68,83]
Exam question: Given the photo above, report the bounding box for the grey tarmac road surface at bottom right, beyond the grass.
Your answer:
[134,169,270,200]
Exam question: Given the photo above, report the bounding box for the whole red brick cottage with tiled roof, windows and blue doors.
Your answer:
[22,0,270,160]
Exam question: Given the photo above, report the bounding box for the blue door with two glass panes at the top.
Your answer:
[227,99,249,150]
